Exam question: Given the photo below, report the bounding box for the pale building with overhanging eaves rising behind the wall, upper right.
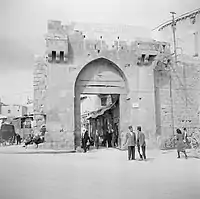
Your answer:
[155,8,200,57]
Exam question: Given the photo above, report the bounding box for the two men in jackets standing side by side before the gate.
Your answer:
[124,126,146,160]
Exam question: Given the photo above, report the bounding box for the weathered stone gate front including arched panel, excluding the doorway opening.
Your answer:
[35,21,173,149]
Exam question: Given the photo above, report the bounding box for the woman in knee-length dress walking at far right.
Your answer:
[176,129,187,159]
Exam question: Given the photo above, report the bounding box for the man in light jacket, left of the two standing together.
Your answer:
[124,126,136,160]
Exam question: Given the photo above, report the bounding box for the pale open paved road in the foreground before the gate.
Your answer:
[0,149,200,199]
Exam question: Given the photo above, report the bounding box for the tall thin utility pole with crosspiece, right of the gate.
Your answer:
[170,12,177,135]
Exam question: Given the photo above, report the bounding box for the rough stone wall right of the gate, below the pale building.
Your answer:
[155,56,200,148]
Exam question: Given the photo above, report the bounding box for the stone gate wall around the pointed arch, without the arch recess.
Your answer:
[35,21,170,149]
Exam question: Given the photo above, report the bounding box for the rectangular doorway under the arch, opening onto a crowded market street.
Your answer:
[80,94,120,148]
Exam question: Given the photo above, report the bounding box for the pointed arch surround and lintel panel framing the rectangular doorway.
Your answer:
[74,58,128,146]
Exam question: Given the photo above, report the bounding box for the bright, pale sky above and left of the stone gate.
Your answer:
[0,0,200,103]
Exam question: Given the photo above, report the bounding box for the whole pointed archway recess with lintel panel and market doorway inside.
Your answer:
[74,58,127,148]
